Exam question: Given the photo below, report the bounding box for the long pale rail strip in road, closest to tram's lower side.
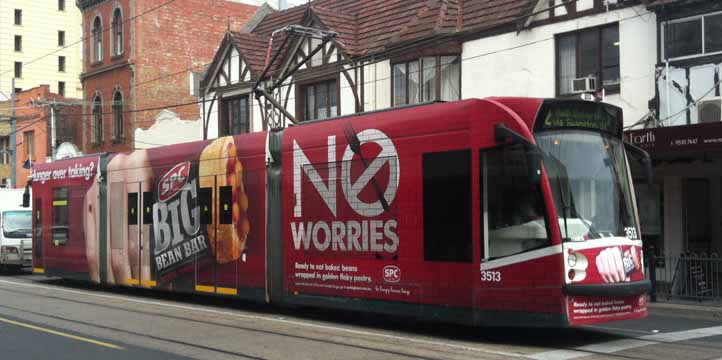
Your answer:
[0,280,529,358]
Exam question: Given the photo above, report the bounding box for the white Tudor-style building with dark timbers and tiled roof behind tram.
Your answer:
[201,0,656,138]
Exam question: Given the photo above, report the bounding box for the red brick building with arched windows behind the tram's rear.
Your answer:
[77,0,257,152]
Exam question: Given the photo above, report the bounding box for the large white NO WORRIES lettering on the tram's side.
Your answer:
[291,129,400,253]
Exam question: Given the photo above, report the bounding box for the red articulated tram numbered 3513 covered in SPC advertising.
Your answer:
[32,98,649,326]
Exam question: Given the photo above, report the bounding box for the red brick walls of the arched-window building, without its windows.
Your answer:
[81,0,257,152]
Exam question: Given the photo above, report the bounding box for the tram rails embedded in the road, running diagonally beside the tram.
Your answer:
[0,280,525,360]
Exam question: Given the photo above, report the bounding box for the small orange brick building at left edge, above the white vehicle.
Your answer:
[0,85,82,188]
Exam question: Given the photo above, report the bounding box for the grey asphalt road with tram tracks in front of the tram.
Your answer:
[0,274,722,360]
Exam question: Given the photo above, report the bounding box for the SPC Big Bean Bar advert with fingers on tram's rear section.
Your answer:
[34,137,265,290]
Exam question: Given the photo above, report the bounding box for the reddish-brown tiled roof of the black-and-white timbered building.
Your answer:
[232,0,532,74]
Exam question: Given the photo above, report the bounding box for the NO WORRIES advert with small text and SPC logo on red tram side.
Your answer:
[284,122,418,301]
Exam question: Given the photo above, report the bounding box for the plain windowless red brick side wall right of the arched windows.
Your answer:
[135,0,256,128]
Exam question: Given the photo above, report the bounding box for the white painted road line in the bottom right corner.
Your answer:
[531,326,722,360]
